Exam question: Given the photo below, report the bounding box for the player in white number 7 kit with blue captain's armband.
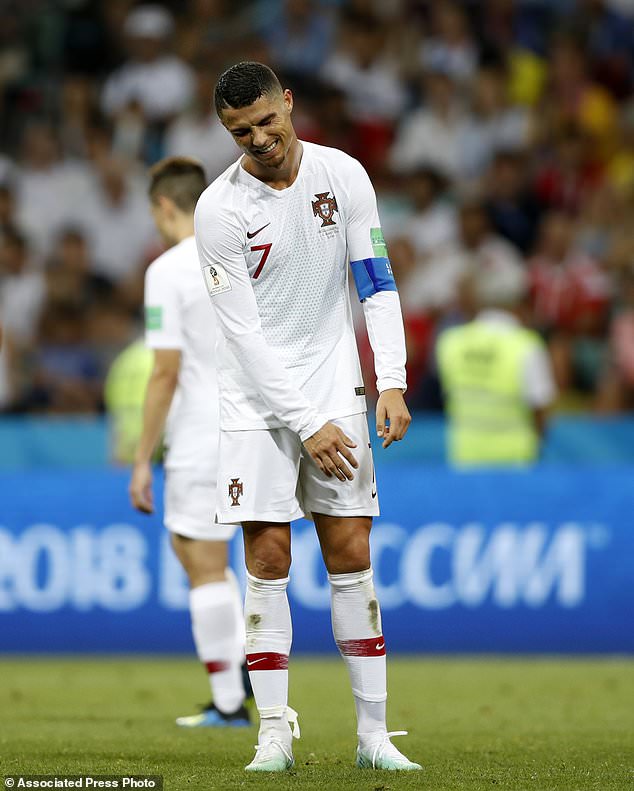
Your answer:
[195,62,420,771]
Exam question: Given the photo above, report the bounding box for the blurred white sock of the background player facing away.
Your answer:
[189,580,245,714]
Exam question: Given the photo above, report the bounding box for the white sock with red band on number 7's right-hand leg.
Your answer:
[328,568,387,746]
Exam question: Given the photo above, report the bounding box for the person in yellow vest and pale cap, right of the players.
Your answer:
[437,270,555,466]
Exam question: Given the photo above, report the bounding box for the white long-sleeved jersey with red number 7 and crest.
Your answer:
[196,142,405,438]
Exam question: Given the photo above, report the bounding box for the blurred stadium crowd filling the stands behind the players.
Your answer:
[0,0,634,413]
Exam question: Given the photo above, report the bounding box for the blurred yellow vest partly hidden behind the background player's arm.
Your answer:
[104,339,154,464]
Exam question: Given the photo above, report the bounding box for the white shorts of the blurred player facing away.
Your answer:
[163,470,236,541]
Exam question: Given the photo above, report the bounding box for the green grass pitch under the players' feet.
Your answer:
[0,658,634,791]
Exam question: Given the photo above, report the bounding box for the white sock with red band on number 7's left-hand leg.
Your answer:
[244,573,292,740]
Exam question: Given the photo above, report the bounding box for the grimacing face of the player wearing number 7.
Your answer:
[220,89,295,168]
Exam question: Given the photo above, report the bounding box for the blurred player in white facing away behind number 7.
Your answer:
[130,157,249,727]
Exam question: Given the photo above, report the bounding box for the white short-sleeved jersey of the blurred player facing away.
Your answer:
[145,236,219,470]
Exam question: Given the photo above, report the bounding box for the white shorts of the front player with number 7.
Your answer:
[216,413,379,523]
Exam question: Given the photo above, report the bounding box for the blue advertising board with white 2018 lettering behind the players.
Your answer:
[0,463,634,653]
